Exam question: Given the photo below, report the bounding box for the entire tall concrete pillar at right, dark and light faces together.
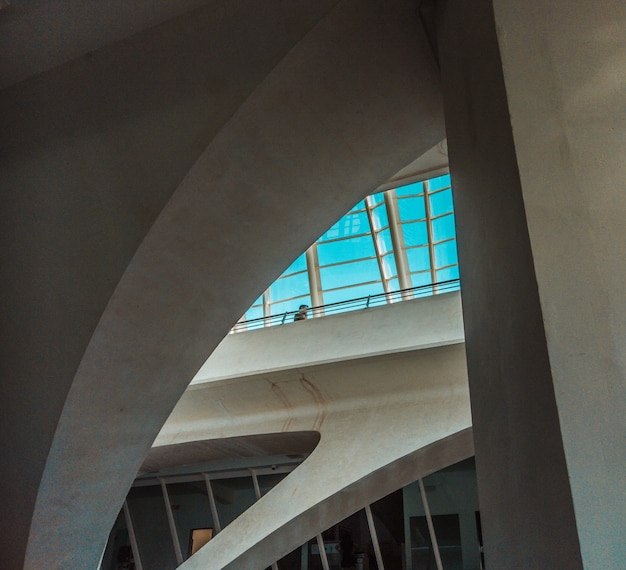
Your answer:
[438,0,626,569]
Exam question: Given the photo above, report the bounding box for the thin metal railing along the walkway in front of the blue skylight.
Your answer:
[231,279,460,333]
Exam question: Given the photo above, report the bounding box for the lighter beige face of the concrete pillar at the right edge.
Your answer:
[494,0,626,569]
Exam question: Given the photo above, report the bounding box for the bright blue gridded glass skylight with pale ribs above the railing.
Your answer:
[236,171,459,321]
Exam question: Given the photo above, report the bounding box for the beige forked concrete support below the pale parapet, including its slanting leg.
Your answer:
[161,344,473,570]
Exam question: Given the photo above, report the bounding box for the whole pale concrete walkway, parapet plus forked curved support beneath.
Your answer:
[153,292,473,570]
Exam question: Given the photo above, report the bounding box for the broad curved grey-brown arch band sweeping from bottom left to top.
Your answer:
[24,0,444,569]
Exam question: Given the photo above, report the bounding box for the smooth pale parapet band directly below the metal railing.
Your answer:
[191,292,464,385]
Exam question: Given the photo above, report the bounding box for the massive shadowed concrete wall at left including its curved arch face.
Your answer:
[0,1,444,568]
